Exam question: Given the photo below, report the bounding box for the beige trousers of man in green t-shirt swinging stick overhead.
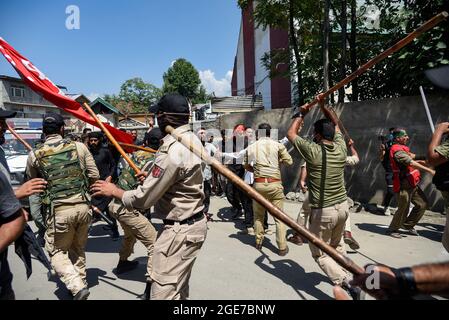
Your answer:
[309,201,349,285]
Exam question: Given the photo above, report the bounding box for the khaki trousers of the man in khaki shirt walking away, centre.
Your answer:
[253,182,287,250]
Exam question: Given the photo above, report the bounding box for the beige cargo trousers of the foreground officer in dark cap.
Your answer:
[150,218,207,300]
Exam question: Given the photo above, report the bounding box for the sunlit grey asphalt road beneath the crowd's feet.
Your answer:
[9,197,449,300]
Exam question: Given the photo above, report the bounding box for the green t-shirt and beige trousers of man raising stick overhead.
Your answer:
[293,132,349,285]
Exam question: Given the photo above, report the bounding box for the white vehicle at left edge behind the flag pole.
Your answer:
[2,130,42,187]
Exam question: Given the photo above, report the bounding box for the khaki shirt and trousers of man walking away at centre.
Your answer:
[244,138,293,250]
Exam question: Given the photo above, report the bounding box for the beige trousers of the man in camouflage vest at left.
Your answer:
[45,203,91,295]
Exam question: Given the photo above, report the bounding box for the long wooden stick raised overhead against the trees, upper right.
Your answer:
[303,11,449,108]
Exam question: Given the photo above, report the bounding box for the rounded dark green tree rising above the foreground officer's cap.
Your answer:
[162,58,205,101]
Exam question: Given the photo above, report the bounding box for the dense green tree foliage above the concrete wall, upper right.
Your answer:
[237,0,449,103]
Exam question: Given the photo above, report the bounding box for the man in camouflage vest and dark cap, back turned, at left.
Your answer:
[27,113,99,300]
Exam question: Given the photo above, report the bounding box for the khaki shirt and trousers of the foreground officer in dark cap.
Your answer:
[122,125,207,300]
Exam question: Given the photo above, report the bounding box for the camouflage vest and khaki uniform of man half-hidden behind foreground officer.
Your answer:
[109,151,157,282]
